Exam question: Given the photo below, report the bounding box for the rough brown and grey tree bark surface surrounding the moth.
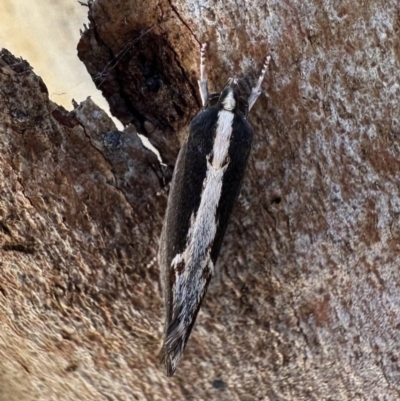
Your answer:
[0,0,400,401]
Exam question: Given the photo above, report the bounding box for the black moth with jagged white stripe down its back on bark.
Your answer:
[158,44,269,376]
